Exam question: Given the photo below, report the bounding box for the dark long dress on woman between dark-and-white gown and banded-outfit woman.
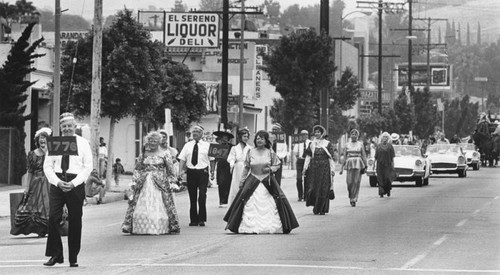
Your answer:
[305,142,333,214]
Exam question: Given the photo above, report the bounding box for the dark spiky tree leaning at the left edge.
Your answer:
[0,23,44,183]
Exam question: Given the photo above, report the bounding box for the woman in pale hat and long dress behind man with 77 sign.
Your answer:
[10,127,52,237]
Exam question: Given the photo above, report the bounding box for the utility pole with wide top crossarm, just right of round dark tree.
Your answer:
[357,0,403,114]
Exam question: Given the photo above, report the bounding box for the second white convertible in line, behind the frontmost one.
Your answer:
[426,144,467,178]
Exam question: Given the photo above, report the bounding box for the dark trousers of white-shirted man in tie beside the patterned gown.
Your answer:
[186,168,208,223]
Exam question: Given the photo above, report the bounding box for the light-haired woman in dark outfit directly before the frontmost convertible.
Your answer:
[375,132,396,198]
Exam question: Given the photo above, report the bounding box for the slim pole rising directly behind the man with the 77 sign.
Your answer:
[52,0,61,136]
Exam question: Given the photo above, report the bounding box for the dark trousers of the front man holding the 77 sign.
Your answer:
[45,184,85,263]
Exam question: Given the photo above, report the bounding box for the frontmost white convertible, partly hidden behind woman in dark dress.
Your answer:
[366,145,432,187]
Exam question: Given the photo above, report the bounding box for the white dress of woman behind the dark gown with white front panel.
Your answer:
[227,143,252,205]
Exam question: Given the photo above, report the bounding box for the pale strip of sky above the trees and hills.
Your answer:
[7,0,356,20]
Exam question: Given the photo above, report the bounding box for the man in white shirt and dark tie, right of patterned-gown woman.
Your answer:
[179,125,210,226]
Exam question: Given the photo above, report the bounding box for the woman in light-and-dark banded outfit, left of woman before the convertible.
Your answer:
[340,129,366,207]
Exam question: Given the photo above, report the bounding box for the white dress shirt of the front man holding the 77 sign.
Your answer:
[43,135,93,187]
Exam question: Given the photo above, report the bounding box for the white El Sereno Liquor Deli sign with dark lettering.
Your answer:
[165,13,219,48]
